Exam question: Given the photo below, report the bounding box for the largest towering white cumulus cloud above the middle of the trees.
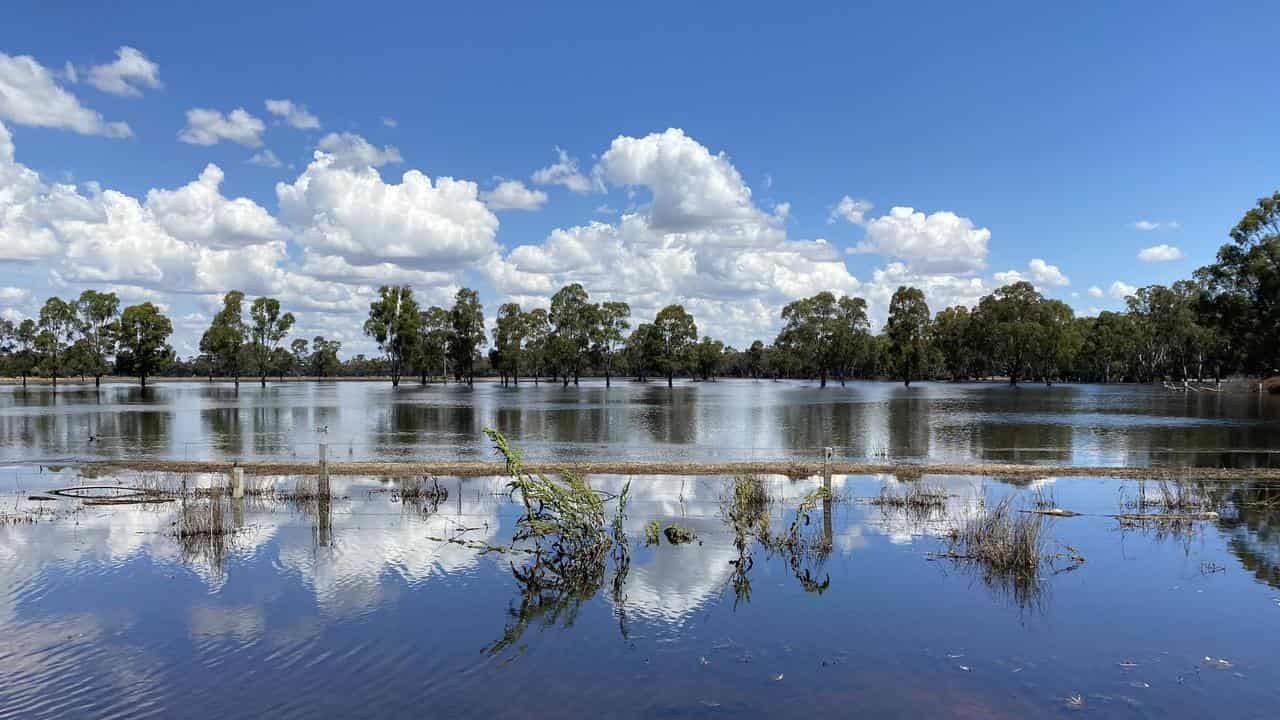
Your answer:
[485,129,860,343]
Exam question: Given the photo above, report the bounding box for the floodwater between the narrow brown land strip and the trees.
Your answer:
[0,380,1280,468]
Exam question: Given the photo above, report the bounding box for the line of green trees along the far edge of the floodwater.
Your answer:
[0,192,1280,386]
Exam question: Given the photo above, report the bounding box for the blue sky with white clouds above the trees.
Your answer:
[0,1,1280,356]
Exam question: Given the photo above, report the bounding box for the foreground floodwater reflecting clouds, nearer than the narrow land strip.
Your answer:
[0,468,1280,720]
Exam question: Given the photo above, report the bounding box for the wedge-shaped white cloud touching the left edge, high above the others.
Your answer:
[0,53,133,137]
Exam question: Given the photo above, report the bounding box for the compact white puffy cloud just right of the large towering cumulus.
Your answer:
[854,208,991,273]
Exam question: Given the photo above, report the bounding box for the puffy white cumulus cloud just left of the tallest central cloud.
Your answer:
[275,136,498,269]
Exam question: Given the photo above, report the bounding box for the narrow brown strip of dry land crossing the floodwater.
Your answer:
[83,460,1280,482]
